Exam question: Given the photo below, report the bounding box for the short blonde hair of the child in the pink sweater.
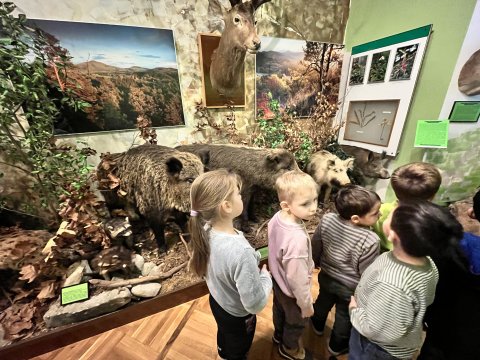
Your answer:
[275,170,318,202]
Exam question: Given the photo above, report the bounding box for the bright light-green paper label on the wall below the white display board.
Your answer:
[414,120,449,148]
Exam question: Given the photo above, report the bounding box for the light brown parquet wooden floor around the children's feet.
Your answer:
[34,273,347,360]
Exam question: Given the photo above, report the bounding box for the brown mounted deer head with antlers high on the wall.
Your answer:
[210,0,271,96]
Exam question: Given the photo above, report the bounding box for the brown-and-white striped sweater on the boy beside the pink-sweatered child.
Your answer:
[312,213,380,289]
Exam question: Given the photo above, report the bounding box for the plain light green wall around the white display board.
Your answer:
[345,0,477,200]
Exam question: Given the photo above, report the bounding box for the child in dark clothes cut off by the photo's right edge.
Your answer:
[418,191,480,360]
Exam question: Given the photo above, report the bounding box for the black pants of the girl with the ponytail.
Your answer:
[209,295,257,360]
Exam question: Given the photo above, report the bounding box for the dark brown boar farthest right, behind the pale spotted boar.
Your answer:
[342,145,390,186]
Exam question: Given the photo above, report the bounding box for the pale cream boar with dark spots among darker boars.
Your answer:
[306,150,354,203]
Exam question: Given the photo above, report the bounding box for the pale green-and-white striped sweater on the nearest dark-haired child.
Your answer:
[350,252,438,359]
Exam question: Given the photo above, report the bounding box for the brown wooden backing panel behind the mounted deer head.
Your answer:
[198,34,245,108]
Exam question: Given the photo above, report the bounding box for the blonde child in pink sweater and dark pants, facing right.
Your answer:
[268,170,318,359]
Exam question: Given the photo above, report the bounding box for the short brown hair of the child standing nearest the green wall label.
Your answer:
[390,162,442,201]
